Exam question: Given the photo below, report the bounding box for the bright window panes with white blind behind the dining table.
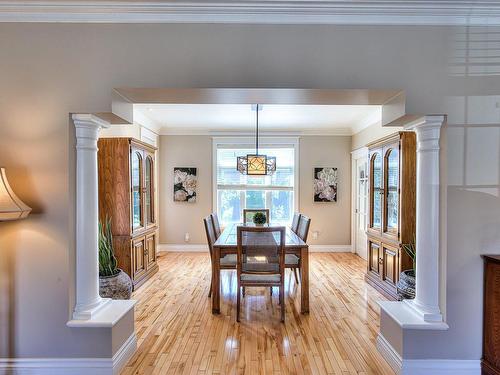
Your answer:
[214,144,296,226]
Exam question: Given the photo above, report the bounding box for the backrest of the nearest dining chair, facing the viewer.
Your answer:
[237,226,286,274]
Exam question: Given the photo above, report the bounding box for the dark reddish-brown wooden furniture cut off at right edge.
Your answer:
[481,255,500,375]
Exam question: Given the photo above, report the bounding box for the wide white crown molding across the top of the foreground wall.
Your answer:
[0,0,500,26]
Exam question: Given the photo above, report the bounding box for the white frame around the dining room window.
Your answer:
[212,136,300,223]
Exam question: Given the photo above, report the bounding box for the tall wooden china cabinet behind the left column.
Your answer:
[97,138,158,289]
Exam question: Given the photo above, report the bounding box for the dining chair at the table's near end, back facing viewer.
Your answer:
[236,226,286,322]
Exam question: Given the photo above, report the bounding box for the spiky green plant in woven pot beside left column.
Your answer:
[99,218,132,299]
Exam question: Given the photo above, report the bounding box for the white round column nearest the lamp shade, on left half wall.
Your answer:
[73,114,110,320]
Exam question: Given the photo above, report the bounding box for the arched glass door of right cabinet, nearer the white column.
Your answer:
[384,145,399,235]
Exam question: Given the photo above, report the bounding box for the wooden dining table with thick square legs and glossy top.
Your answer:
[212,224,309,314]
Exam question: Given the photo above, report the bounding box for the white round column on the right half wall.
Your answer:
[405,116,445,322]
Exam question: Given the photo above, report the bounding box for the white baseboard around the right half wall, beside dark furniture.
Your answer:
[377,333,481,375]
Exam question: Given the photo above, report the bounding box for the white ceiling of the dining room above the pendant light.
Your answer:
[134,104,381,135]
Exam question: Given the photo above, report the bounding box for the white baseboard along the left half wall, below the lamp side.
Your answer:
[0,333,137,375]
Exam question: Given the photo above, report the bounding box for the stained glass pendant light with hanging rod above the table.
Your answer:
[236,104,276,176]
